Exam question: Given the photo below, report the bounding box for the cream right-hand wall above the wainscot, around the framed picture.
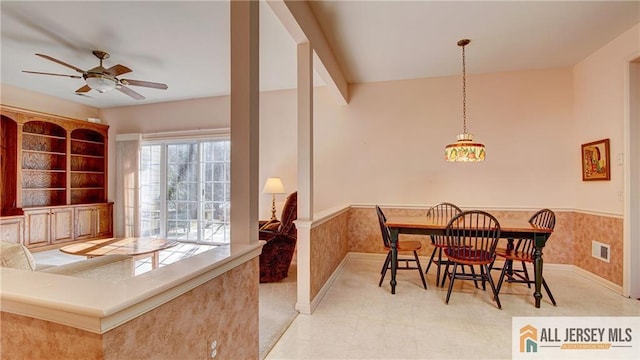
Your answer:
[571,25,640,215]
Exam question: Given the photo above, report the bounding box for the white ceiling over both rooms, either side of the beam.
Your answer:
[0,1,640,108]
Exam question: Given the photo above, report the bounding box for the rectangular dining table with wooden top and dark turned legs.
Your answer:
[385,216,553,308]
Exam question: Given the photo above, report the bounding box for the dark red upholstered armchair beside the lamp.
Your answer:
[259,192,298,283]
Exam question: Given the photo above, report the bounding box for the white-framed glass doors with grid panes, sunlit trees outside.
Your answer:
[140,139,231,244]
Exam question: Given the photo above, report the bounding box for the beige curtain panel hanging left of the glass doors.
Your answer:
[114,134,140,237]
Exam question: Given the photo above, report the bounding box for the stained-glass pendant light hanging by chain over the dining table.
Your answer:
[444,39,485,162]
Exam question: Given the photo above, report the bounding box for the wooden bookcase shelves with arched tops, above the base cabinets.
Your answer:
[0,106,109,211]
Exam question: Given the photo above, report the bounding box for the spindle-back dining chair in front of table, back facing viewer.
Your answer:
[444,210,502,309]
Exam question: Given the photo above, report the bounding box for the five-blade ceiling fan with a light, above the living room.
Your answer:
[22,50,168,100]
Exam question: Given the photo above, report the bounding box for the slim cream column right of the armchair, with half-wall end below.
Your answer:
[296,42,313,314]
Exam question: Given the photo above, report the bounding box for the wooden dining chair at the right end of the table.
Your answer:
[494,209,556,306]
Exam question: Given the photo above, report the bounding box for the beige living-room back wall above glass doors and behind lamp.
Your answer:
[100,90,297,219]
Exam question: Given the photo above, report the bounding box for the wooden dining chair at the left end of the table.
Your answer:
[376,205,427,289]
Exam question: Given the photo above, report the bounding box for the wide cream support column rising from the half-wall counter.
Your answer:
[230,1,260,246]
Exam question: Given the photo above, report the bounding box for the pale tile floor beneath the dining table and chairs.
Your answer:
[266,256,640,360]
